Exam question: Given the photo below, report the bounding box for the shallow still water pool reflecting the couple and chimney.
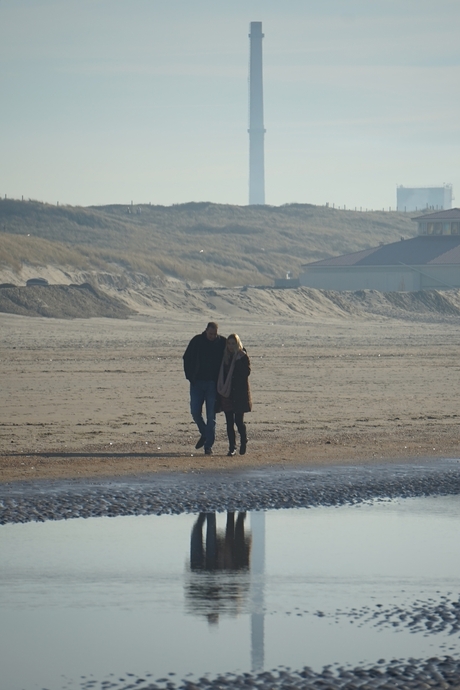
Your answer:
[0,496,460,690]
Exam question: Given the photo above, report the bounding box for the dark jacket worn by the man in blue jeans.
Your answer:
[183,331,226,383]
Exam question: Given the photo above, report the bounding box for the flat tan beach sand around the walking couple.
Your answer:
[0,313,460,482]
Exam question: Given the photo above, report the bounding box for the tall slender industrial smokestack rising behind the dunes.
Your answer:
[248,22,265,205]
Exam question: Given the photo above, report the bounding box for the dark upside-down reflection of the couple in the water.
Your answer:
[186,512,251,624]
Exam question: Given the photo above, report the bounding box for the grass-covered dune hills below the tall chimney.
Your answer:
[0,199,416,286]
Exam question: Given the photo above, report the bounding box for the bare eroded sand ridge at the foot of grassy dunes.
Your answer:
[0,264,460,323]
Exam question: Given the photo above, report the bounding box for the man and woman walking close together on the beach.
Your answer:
[183,321,252,456]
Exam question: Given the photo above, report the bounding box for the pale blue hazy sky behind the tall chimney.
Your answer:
[0,0,460,210]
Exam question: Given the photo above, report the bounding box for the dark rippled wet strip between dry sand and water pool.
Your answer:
[0,459,460,524]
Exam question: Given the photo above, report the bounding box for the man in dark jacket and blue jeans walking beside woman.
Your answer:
[183,321,226,455]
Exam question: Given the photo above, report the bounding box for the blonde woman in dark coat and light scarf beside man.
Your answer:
[217,333,252,455]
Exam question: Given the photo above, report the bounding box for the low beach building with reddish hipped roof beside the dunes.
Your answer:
[299,208,460,292]
